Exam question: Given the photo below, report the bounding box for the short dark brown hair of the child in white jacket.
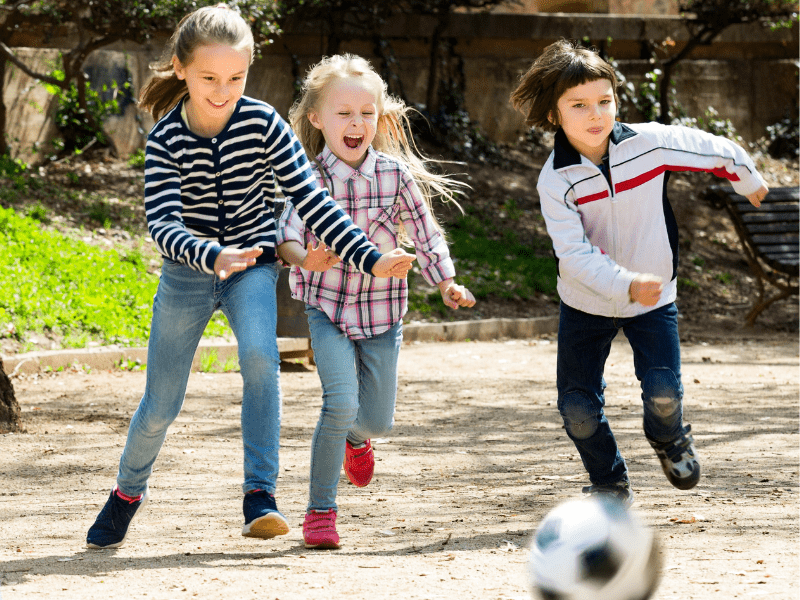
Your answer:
[511,40,619,131]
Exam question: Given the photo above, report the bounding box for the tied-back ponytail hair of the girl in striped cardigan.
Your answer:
[139,4,255,121]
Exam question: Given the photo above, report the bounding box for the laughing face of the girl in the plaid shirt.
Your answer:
[308,77,379,169]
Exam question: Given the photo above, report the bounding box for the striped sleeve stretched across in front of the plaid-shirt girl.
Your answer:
[265,114,381,275]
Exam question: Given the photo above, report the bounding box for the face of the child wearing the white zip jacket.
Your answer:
[550,79,617,164]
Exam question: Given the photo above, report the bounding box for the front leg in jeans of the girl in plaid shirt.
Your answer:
[306,308,359,510]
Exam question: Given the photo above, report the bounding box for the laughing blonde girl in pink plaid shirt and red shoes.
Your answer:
[277,55,475,548]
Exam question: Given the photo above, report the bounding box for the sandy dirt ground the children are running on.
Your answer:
[0,332,800,600]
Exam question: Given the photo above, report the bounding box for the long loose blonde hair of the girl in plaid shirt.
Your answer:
[289,54,469,245]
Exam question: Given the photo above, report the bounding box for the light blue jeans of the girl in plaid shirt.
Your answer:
[306,307,403,510]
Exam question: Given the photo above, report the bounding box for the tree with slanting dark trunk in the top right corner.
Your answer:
[658,0,797,123]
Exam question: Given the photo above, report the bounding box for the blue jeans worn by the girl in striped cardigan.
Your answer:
[117,260,281,496]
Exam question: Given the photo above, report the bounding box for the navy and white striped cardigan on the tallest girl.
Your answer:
[145,96,380,274]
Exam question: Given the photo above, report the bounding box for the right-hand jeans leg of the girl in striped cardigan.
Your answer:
[220,265,281,495]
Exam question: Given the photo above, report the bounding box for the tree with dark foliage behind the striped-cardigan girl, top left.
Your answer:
[0,0,279,155]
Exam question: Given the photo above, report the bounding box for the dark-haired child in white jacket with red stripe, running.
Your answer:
[511,40,767,504]
